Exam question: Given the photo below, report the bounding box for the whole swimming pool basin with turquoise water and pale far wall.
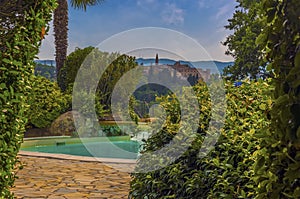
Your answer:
[21,138,140,159]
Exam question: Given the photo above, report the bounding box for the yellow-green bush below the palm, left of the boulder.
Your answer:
[27,76,71,128]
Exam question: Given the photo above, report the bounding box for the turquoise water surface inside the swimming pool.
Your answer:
[22,141,140,159]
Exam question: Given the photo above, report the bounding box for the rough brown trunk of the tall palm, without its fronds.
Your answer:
[53,0,68,75]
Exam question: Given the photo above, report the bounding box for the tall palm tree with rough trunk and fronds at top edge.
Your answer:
[53,0,103,74]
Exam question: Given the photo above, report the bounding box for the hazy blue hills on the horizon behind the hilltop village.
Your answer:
[136,58,234,73]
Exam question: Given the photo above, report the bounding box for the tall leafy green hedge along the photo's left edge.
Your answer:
[0,0,56,199]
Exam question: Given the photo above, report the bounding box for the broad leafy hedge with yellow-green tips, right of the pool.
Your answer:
[130,81,272,199]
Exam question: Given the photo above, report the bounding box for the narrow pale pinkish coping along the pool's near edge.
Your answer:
[18,150,137,165]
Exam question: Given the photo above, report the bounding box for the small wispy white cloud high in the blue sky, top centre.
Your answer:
[161,3,184,25]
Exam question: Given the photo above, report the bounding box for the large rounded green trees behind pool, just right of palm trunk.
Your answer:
[57,47,137,119]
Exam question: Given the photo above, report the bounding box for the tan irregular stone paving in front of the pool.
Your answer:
[12,154,133,199]
